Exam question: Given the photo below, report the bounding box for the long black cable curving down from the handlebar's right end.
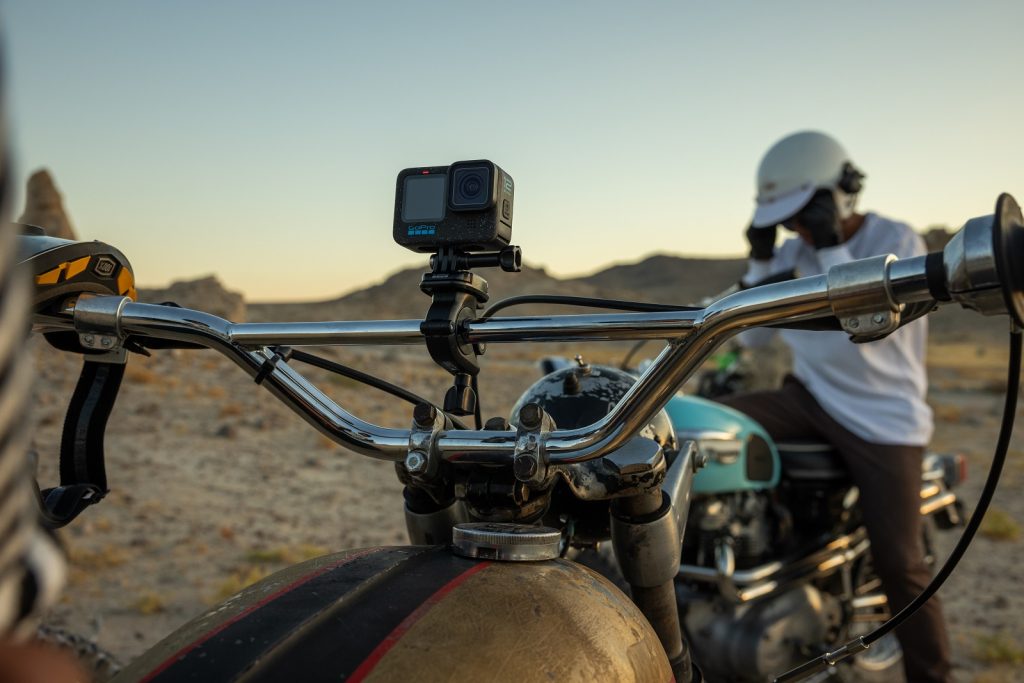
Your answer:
[773,325,1021,683]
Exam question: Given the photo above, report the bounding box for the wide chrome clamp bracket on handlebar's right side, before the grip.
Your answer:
[828,254,903,343]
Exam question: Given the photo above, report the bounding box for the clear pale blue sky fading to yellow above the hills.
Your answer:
[0,0,1024,300]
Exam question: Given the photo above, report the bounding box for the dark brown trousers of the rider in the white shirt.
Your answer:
[721,377,951,683]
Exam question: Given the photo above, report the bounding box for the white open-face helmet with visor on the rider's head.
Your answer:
[752,131,864,227]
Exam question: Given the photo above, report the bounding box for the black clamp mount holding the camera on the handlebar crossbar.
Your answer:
[420,246,522,415]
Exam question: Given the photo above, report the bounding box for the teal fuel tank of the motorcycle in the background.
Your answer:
[665,394,781,494]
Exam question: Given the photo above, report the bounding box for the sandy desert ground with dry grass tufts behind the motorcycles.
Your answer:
[28,335,1024,683]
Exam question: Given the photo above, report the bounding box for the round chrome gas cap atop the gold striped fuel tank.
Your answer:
[452,522,562,562]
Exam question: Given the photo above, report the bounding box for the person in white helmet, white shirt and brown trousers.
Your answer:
[723,132,950,683]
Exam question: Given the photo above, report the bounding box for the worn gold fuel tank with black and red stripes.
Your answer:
[115,546,673,683]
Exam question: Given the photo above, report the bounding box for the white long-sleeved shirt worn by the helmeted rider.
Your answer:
[739,213,933,445]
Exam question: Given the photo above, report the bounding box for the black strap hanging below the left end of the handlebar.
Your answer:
[40,358,125,528]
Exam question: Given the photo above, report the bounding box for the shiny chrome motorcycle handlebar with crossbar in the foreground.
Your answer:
[37,196,1024,465]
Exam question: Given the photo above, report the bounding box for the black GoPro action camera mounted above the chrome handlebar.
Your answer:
[394,160,515,253]
